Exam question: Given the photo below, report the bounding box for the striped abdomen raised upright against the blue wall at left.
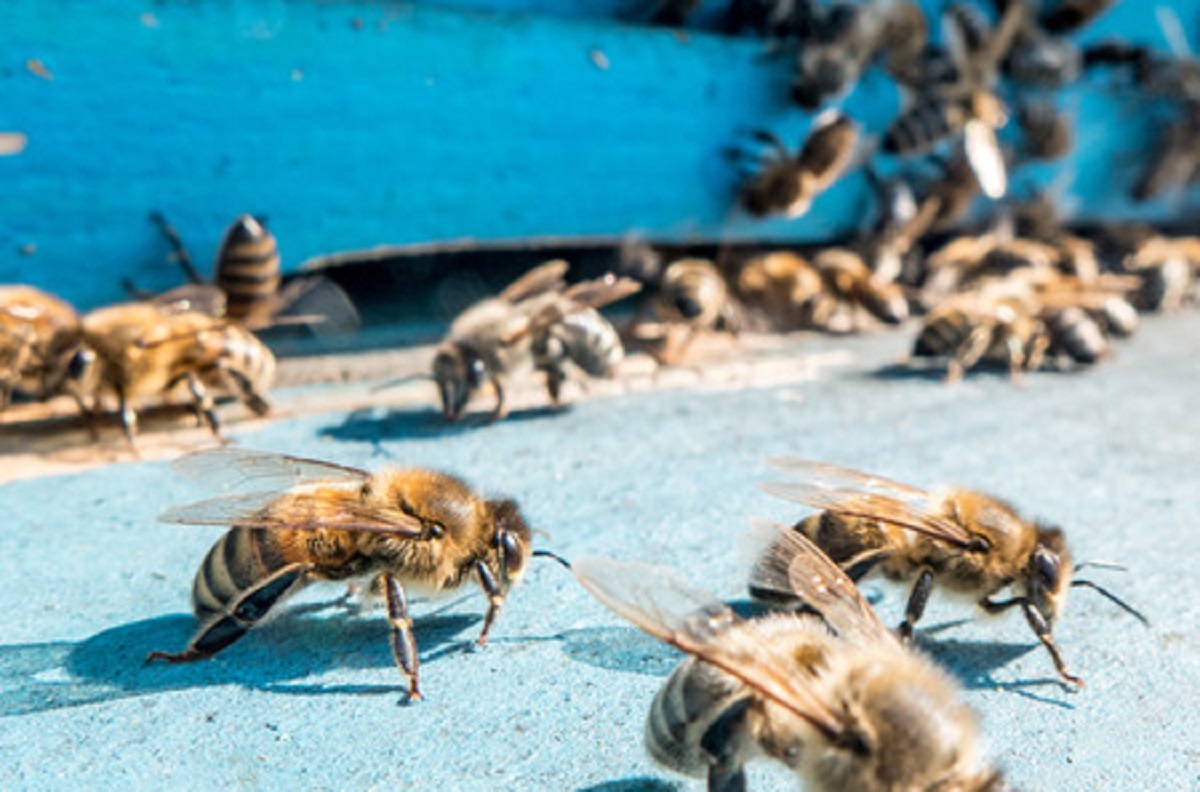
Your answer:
[216,215,281,324]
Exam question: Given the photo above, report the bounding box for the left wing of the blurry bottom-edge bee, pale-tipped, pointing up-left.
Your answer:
[572,556,845,739]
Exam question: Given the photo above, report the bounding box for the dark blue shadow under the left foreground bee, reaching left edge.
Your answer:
[0,608,481,718]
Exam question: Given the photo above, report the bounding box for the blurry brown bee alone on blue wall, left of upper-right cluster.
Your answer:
[739,110,859,218]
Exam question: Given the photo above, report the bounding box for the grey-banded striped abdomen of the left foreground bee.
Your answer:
[192,528,287,622]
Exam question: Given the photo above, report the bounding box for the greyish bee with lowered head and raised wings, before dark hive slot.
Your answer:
[433,260,641,421]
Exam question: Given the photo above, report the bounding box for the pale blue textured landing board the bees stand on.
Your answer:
[0,313,1200,792]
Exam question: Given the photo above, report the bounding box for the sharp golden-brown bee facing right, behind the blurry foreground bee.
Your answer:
[751,457,1147,686]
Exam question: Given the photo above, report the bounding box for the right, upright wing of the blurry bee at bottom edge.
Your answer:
[754,521,893,642]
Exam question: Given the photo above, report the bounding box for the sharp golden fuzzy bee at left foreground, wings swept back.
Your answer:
[149,449,548,700]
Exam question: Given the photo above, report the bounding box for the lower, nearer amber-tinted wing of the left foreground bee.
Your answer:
[158,490,424,539]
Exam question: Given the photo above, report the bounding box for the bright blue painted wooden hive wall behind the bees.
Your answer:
[0,0,1200,306]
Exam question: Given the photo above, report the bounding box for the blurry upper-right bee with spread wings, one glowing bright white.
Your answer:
[882,2,1024,198]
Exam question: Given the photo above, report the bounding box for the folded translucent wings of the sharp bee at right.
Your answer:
[760,457,976,547]
